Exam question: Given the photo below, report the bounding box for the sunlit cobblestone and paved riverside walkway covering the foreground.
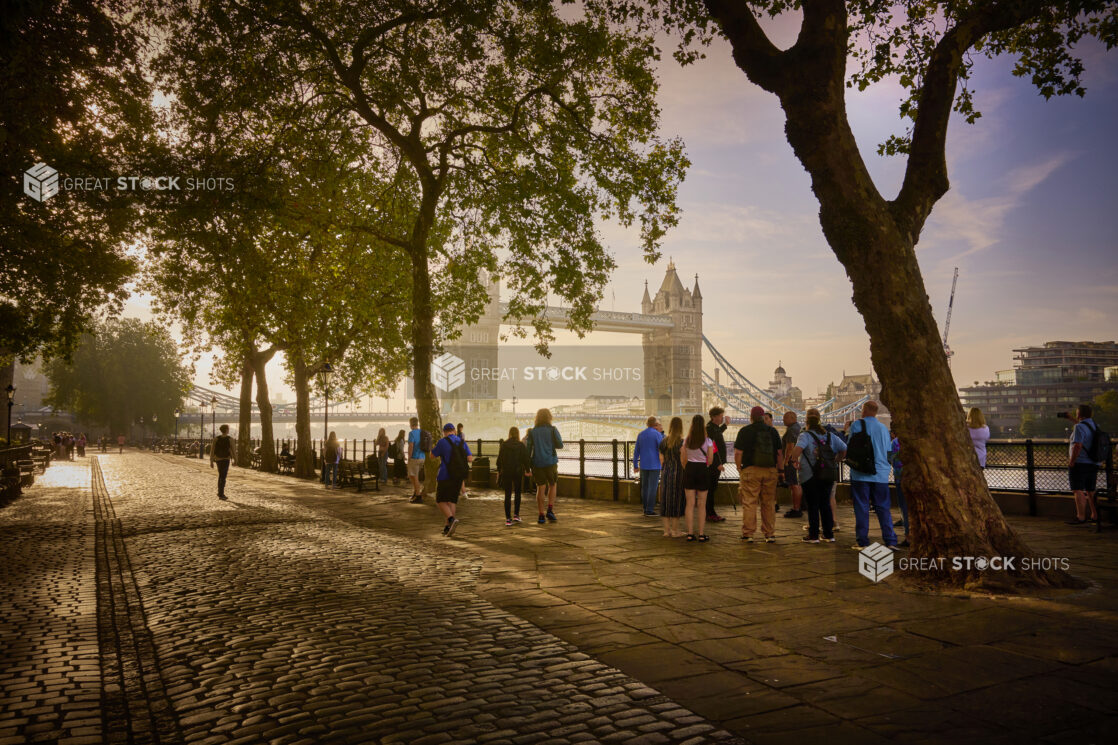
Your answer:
[0,452,1118,745]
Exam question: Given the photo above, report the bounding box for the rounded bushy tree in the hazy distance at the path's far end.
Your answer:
[46,318,191,434]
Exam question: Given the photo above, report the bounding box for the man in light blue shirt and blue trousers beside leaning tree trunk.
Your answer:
[846,400,897,551]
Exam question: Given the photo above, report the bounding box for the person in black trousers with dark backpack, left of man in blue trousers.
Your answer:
[786,408,846,544]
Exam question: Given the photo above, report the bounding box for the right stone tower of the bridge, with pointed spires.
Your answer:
[641,261,702,411]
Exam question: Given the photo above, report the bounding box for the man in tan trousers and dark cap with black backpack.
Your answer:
[733,406,784,544]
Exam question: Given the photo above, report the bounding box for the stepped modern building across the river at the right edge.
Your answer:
[959,341,1118,431]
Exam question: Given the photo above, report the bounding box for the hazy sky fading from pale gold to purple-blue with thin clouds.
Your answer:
[126,21,1118,409]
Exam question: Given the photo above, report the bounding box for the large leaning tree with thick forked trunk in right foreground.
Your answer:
[617,0,1118,587]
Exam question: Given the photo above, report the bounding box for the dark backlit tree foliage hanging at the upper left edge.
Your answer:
[0,0,153,371]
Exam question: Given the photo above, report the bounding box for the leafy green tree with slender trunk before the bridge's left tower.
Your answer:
[148,0,686,481]
